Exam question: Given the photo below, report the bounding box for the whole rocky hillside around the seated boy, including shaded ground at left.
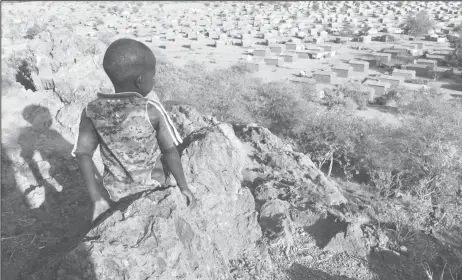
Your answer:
[1,1,460,280]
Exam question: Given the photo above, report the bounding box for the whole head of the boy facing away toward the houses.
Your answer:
[103,39,156,96]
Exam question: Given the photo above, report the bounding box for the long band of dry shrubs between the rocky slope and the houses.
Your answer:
[156,61,462,234]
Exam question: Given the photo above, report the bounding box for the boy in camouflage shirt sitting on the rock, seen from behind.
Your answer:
[72,39,196,220]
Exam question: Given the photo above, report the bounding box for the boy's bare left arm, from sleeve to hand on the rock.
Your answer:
[77,155,110,221]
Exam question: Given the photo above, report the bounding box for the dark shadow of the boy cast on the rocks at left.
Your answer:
[18,105,101,225]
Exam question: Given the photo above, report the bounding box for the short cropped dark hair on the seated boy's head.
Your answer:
[103,38,156,84]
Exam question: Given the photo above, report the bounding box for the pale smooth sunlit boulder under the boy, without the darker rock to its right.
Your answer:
[29,119,261,279]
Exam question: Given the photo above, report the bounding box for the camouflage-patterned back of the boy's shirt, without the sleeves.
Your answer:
[86,93,160,201]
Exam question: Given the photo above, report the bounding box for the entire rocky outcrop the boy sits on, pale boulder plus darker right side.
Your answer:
[22,106,354,279]
